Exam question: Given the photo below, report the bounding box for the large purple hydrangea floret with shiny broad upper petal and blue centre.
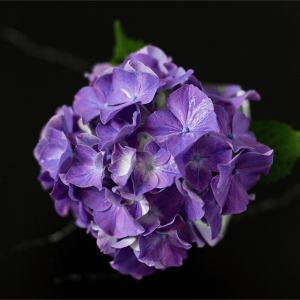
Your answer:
[143,84,219,156]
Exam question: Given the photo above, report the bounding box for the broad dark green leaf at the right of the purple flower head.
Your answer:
[249,120,300,184]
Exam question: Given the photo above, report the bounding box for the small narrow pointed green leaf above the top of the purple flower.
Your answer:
[110,20,146,65]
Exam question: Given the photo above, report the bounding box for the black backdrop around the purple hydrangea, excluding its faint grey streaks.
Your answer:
[0,2,300,298]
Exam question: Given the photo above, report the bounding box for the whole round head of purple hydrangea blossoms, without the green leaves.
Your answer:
[34,45,273,279]
